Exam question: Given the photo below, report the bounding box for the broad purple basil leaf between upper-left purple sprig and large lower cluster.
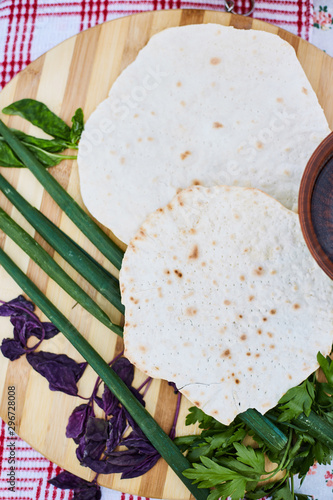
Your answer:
[27,351,87,396]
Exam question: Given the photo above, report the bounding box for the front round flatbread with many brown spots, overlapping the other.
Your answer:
[120,186,333,424]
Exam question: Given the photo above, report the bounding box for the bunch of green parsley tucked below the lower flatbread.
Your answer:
[176,353,333,500]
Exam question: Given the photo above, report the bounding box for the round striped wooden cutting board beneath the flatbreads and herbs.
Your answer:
[0,10,333,500]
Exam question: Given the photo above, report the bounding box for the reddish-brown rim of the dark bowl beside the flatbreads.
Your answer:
[298,132,333,279]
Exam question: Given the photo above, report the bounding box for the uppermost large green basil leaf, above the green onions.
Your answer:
[2,99,71,141]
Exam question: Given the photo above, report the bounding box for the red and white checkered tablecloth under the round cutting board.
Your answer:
[0,0,333,500]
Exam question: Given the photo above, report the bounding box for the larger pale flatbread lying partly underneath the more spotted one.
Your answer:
[78,24,330,244]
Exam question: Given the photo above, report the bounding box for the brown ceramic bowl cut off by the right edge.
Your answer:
[298,132,333,279]
